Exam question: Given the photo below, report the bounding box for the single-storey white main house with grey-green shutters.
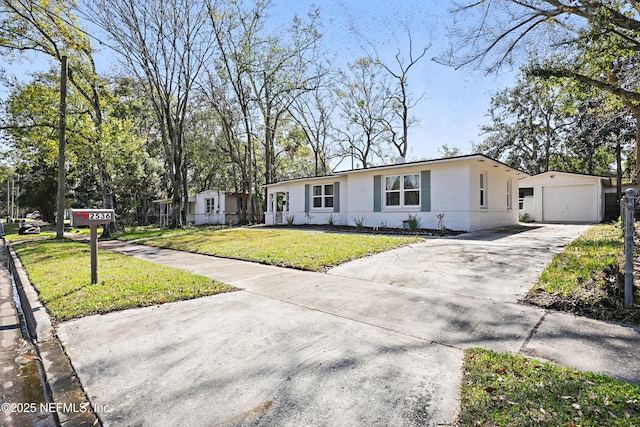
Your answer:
[265,154,528,231]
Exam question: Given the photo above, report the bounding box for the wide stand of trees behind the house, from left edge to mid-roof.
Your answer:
[0,0,428,227]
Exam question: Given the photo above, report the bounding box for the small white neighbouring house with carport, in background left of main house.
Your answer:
[154,190,242,226]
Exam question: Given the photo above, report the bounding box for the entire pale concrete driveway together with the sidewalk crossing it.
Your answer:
[50,226,640,426]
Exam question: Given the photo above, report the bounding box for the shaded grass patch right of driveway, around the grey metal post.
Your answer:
[525,224,640,324]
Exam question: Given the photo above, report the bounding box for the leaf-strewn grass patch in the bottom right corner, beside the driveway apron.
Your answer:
[459,348,640,427]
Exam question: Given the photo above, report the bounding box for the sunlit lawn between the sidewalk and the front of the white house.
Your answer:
[125,228,422,271]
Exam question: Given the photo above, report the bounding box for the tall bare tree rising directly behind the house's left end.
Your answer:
[209,0,320,220]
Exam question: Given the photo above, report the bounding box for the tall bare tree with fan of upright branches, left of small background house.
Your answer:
[88,0,212,227]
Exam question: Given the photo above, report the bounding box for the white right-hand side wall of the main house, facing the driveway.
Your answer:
[469,164,518,231]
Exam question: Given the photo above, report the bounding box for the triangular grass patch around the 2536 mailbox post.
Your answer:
[14,239,234,320]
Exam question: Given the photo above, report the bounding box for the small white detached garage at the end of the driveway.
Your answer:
[519,171,611,223]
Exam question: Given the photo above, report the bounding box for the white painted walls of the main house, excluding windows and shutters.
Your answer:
[265,157,518,231]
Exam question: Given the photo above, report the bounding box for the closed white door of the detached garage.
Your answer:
[542,184,598,222]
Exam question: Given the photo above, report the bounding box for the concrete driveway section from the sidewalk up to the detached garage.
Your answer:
[329,224,589,302]
